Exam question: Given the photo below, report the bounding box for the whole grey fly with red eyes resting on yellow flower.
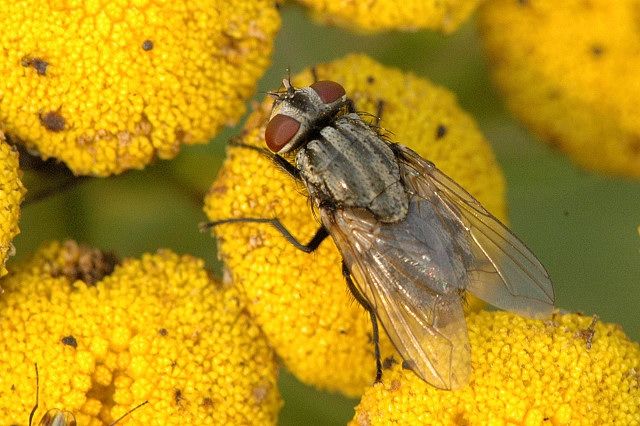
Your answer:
[204,79,554,389]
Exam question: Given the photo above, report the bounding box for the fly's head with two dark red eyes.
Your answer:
[264,79,347,154]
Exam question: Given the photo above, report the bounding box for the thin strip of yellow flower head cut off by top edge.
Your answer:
[298,0,480,34]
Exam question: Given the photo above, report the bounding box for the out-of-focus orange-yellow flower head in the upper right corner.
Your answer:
[479,0,640,177]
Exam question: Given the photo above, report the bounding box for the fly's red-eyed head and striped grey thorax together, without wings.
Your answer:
[265,80,409,223]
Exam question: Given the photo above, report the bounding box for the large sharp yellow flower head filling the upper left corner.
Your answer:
[0,0,280,176]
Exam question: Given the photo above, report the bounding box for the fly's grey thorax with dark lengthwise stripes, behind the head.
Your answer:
[296,114,409,223]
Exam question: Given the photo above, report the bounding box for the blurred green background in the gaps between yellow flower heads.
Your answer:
[15,6,640,425]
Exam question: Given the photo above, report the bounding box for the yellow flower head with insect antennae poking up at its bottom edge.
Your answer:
[0,242,281,425]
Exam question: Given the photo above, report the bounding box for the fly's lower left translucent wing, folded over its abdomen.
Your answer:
[320,198,471,389]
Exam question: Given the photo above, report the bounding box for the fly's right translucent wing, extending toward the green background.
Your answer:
[393,145,555,317]
